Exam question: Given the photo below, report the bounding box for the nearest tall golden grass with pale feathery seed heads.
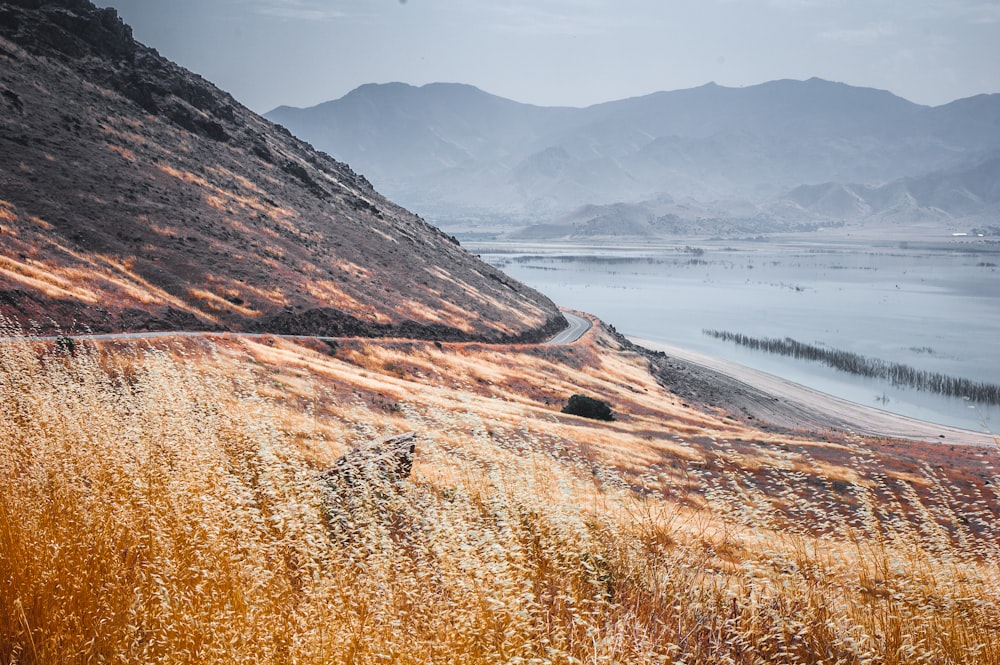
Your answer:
[0,332,1000,664]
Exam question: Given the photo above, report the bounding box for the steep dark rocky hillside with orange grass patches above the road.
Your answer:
[0,0,564,341]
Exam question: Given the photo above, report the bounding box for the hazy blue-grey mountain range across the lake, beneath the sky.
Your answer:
[265,78,1000,236]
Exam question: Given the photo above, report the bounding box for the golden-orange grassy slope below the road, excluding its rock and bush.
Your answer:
[0,320,1000,664]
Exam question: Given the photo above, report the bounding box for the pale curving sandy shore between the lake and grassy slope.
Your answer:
[628,337,1000,446]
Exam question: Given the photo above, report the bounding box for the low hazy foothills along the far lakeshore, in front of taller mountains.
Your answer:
[506,156,1000,241]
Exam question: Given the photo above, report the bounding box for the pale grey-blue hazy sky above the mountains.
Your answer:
[103,0,1000,112]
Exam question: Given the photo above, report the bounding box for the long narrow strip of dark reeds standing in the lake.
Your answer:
[703,330,1000,404]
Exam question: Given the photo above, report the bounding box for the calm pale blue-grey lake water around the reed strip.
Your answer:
[470,236,1000,432]
